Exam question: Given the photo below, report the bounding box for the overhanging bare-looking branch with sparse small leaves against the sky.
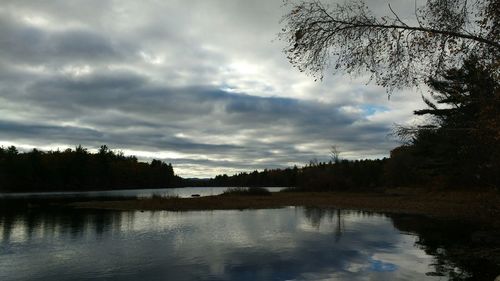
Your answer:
[279,0,500,91]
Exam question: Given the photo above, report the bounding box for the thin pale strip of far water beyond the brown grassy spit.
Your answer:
[0,187,284,198]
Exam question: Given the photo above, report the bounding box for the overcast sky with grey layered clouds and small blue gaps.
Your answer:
[0,0,422,177]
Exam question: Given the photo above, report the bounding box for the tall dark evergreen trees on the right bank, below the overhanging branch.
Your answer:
[391,58,500,186]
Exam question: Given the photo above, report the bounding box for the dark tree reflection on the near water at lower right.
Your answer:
[298,207,500,281]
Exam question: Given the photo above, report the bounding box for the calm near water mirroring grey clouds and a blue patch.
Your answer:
[0,207,492,281]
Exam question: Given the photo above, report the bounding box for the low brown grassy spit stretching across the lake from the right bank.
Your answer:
[69,188,500,225]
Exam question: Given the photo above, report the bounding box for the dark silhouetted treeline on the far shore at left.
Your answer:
[0,145,179,192]
